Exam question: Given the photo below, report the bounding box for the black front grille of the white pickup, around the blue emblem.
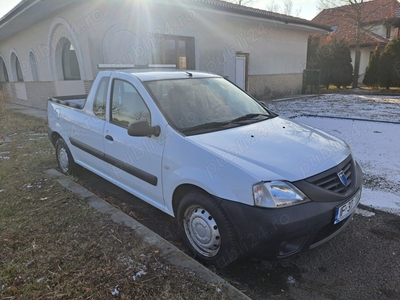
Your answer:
[307,156,354,194]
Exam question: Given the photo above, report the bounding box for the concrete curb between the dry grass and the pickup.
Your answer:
[46,169,251,300]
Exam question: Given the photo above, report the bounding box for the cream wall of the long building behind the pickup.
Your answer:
[0,1,316,108]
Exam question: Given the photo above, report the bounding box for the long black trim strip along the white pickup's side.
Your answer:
[69,138,158,186]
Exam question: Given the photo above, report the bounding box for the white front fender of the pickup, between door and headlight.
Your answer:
[162,127,259,215]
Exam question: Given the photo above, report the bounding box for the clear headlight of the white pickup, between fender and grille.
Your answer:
[253,181,310,208]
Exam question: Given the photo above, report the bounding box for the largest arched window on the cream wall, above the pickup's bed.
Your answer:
[56,37,81,80]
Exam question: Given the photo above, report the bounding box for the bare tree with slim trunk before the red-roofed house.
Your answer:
[317,0,390,88]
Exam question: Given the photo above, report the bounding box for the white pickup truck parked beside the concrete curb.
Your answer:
[48,69,362,267]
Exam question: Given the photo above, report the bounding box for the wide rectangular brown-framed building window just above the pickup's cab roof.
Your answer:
[152,36,195,70]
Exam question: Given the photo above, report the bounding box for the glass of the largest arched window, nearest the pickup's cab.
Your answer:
[60,38,81,80]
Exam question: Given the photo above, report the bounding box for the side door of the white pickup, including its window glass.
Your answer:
[104,77,165,210]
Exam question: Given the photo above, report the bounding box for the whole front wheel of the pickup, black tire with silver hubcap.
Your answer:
[177,191,239,268]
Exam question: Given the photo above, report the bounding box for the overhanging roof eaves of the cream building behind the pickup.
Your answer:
[0,0,330,40]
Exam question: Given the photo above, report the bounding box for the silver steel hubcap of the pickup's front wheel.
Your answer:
[183,206,221,257]
